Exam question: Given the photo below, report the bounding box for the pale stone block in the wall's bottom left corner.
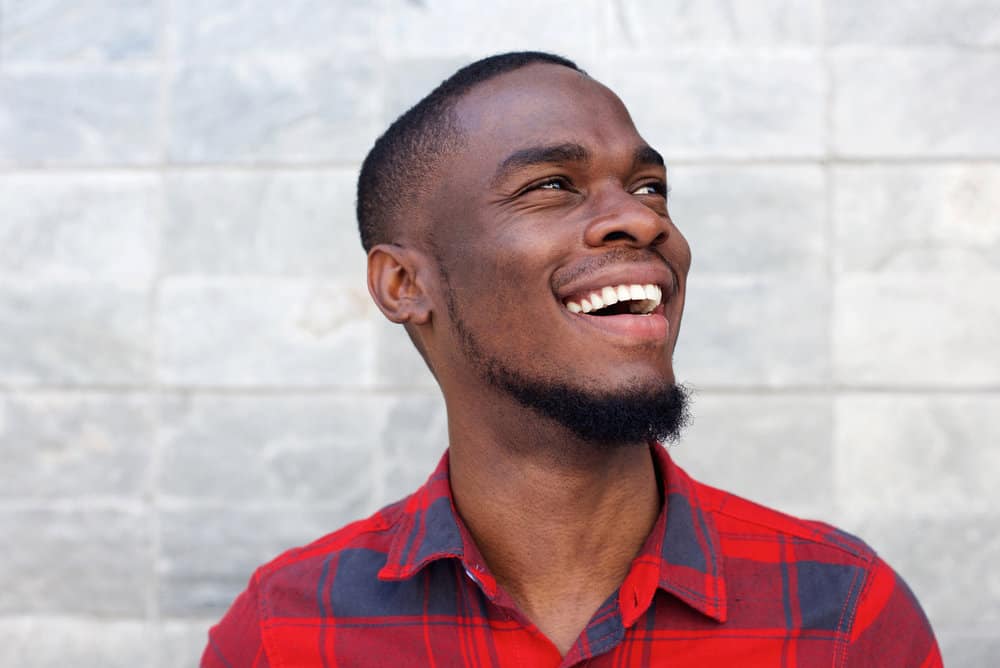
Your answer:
[0,617,153,668]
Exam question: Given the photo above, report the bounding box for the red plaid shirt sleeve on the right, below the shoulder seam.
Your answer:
[845,557,943,668]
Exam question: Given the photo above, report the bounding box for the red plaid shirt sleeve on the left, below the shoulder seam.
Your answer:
[201,573,271,668]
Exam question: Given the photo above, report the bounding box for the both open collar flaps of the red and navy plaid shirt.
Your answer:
[379,444,726,626]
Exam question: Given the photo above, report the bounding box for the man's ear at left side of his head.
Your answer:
[368,244,431,325]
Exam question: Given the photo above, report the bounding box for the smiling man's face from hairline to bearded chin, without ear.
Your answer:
[420,65,690,440]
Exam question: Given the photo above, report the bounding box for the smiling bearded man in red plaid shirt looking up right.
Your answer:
[203,53,941,667]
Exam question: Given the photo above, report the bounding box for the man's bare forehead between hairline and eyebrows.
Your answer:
[455,64,644,160]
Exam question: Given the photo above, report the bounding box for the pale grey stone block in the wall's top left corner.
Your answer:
[0,0,161,63]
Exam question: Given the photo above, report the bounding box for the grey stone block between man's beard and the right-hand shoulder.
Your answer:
[670,392,833,518]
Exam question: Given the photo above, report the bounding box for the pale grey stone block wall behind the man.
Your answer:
[0,0,1000,668]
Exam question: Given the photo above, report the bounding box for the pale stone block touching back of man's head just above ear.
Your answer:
[163,170,367,285]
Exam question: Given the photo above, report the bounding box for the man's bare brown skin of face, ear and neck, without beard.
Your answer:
[369,64,691,655]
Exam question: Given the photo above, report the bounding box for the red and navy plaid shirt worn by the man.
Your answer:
[202,446,942,668]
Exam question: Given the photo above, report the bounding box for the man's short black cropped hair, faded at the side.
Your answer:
[357,51,586,251]
